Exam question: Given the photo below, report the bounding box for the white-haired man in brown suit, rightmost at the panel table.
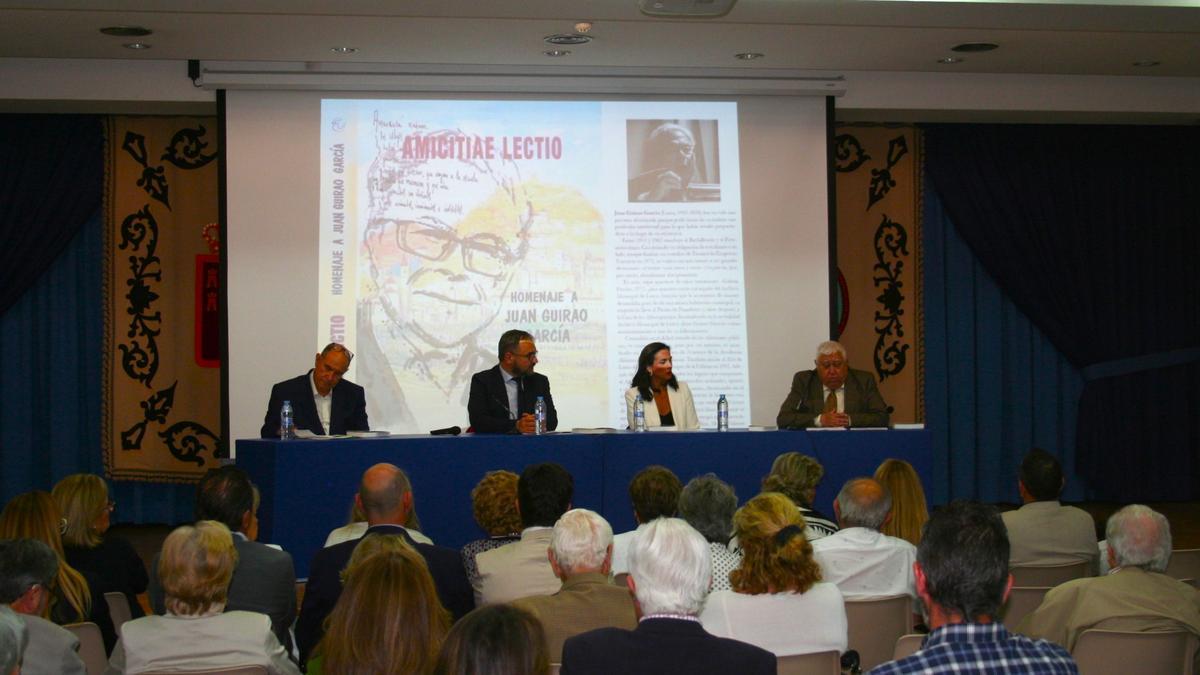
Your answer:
[775,340,888,429]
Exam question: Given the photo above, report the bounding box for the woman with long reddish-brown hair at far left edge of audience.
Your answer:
[0,490,116,652]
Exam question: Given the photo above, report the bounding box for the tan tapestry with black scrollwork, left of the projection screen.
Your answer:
[102,117,221,482]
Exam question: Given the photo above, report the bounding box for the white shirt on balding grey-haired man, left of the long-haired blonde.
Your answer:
[812,527,917,598]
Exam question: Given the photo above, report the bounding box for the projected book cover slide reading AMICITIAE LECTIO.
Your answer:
[318,100,750,434]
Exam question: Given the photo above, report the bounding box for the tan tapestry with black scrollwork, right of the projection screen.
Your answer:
[834,125,924,423]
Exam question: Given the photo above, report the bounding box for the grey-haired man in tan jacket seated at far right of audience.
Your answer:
[1016,504,1200,650]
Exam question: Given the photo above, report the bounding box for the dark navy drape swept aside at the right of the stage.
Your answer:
[925,125,1200,501]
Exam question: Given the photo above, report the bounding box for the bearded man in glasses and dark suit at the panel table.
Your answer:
[467,330,558,434]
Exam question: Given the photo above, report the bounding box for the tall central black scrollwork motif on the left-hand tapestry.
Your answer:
[118,204,162,387]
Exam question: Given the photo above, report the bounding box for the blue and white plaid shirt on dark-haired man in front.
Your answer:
[871,622,1079,675]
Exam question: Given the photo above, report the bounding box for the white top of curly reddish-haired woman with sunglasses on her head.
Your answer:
[700,581,847,656]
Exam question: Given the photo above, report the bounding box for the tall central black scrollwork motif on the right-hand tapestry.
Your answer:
[872,214,910,382]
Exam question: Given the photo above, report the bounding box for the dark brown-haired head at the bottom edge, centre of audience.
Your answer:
[433,604,550,675]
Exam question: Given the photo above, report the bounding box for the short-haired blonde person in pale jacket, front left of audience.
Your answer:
[108,520,300,675]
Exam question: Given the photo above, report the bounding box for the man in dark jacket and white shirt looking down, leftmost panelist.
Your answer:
[259,342,370,438]
